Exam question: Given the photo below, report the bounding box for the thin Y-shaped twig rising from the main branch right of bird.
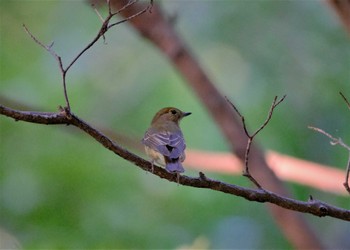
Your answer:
[226,95,286,189]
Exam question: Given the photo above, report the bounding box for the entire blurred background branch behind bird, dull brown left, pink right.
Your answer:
[0,95,348,195]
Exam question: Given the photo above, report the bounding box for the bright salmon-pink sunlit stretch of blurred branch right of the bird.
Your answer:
[185,150,347,195]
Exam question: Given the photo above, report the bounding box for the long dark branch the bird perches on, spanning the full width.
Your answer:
[0,105,350,221]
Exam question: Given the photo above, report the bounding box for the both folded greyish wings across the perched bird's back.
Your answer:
[142,129,186,159]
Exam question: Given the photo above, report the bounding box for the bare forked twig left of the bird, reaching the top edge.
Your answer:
[23,0,153,114]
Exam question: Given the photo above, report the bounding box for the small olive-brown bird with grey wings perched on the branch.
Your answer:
[142,107,191,178]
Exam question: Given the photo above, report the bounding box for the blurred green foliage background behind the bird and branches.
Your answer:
[0,0,350,249]
